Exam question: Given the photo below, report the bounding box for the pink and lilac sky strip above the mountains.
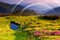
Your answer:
[0,0,60,4]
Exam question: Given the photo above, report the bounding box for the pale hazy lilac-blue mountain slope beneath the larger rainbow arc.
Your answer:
[22,3,60,14]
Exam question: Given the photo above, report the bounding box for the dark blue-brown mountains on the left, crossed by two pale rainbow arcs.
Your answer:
[0,2,36,16]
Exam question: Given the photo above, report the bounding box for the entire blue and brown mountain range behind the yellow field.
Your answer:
[0,2,60,15]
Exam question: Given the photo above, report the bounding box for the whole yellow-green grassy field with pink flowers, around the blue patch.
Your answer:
[0,16,60,40]
